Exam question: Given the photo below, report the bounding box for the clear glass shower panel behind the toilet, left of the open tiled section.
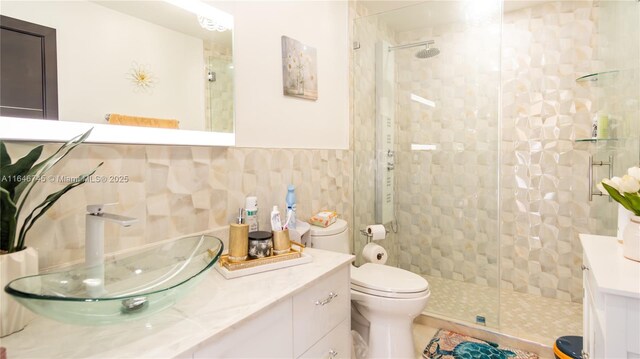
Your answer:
[353,1,502,326]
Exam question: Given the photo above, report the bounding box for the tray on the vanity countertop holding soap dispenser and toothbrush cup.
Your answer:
[215,241,312,279]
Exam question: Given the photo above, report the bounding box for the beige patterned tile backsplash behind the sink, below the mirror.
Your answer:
[8,143,352,269]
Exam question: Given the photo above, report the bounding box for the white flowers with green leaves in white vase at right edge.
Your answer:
[598,167,640,262]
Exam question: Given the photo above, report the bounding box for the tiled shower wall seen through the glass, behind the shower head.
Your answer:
[396,11,500,290]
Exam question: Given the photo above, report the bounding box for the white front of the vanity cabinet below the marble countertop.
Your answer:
[193,264,351,359]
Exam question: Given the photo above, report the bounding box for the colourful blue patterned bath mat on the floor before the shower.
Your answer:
[422,329,538,359]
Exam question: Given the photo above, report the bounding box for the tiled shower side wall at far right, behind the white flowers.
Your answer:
[596,1,640,231]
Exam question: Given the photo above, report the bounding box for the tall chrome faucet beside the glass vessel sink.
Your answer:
[84,204,138,297]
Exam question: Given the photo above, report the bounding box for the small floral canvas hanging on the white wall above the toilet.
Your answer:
[282,36,318,101]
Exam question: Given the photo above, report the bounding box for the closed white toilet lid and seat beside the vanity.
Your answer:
[351,263,429,299]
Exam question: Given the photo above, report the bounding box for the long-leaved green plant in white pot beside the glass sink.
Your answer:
[0,130,102,337]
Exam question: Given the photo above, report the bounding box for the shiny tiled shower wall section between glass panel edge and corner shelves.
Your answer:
[501,1,603,302]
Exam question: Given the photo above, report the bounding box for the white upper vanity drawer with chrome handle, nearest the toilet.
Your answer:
[293,265,351,357]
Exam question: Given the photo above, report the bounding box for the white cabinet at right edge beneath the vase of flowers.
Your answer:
[580,234,640,359]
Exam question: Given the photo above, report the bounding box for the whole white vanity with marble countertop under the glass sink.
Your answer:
[0,248,354,359]
